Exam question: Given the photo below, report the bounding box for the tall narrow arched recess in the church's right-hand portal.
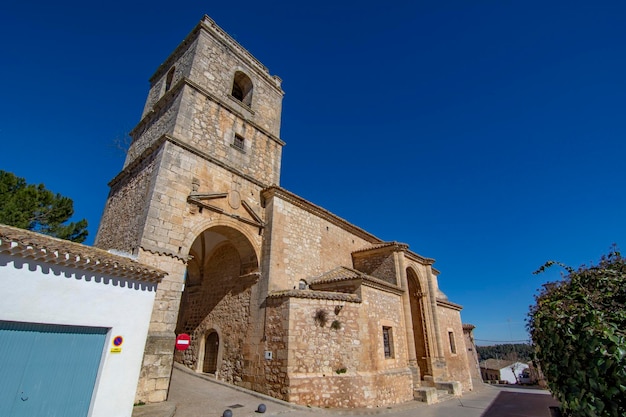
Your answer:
[406,268,432,379]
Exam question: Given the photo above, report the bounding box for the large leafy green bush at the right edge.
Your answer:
[528,248,626,417]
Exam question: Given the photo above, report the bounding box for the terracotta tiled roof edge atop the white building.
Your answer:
[0,225,167,283]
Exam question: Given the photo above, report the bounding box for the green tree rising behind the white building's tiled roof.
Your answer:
[0,170,88,243]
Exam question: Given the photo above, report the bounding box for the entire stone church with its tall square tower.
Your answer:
[95,16,472,407]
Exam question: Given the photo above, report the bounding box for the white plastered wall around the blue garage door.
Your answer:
[0,250,156,417]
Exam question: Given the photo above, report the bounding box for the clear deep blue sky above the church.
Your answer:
[0,0,626,344]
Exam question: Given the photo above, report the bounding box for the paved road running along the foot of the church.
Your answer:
[133,365,557,417]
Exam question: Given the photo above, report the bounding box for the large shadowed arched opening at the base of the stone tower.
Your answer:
[175,226,259,383]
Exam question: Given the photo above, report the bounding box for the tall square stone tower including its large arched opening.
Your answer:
[95,16,284,402]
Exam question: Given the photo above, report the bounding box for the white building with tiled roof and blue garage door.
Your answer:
[0,225,166,417]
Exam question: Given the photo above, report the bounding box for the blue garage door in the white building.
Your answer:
[0,321,108,417]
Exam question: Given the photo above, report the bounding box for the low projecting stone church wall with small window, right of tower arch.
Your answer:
[268,287,413,407]
